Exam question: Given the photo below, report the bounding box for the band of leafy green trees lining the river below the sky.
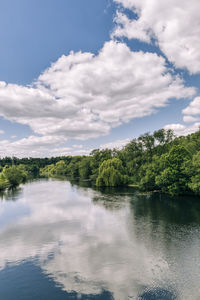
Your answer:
[0,129,200,196]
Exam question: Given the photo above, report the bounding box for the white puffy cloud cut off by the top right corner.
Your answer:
[113,0,200,74]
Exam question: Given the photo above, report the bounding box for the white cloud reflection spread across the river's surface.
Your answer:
[0,181,200,300]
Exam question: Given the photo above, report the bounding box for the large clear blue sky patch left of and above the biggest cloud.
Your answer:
[0,0,115,84]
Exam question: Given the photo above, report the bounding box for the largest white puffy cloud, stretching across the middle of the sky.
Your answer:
[0,41,195,155]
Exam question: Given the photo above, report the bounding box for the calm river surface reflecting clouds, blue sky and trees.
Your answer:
[0,180,200,300]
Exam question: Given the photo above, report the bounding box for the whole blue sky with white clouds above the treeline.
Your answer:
[0,0,200,157]
